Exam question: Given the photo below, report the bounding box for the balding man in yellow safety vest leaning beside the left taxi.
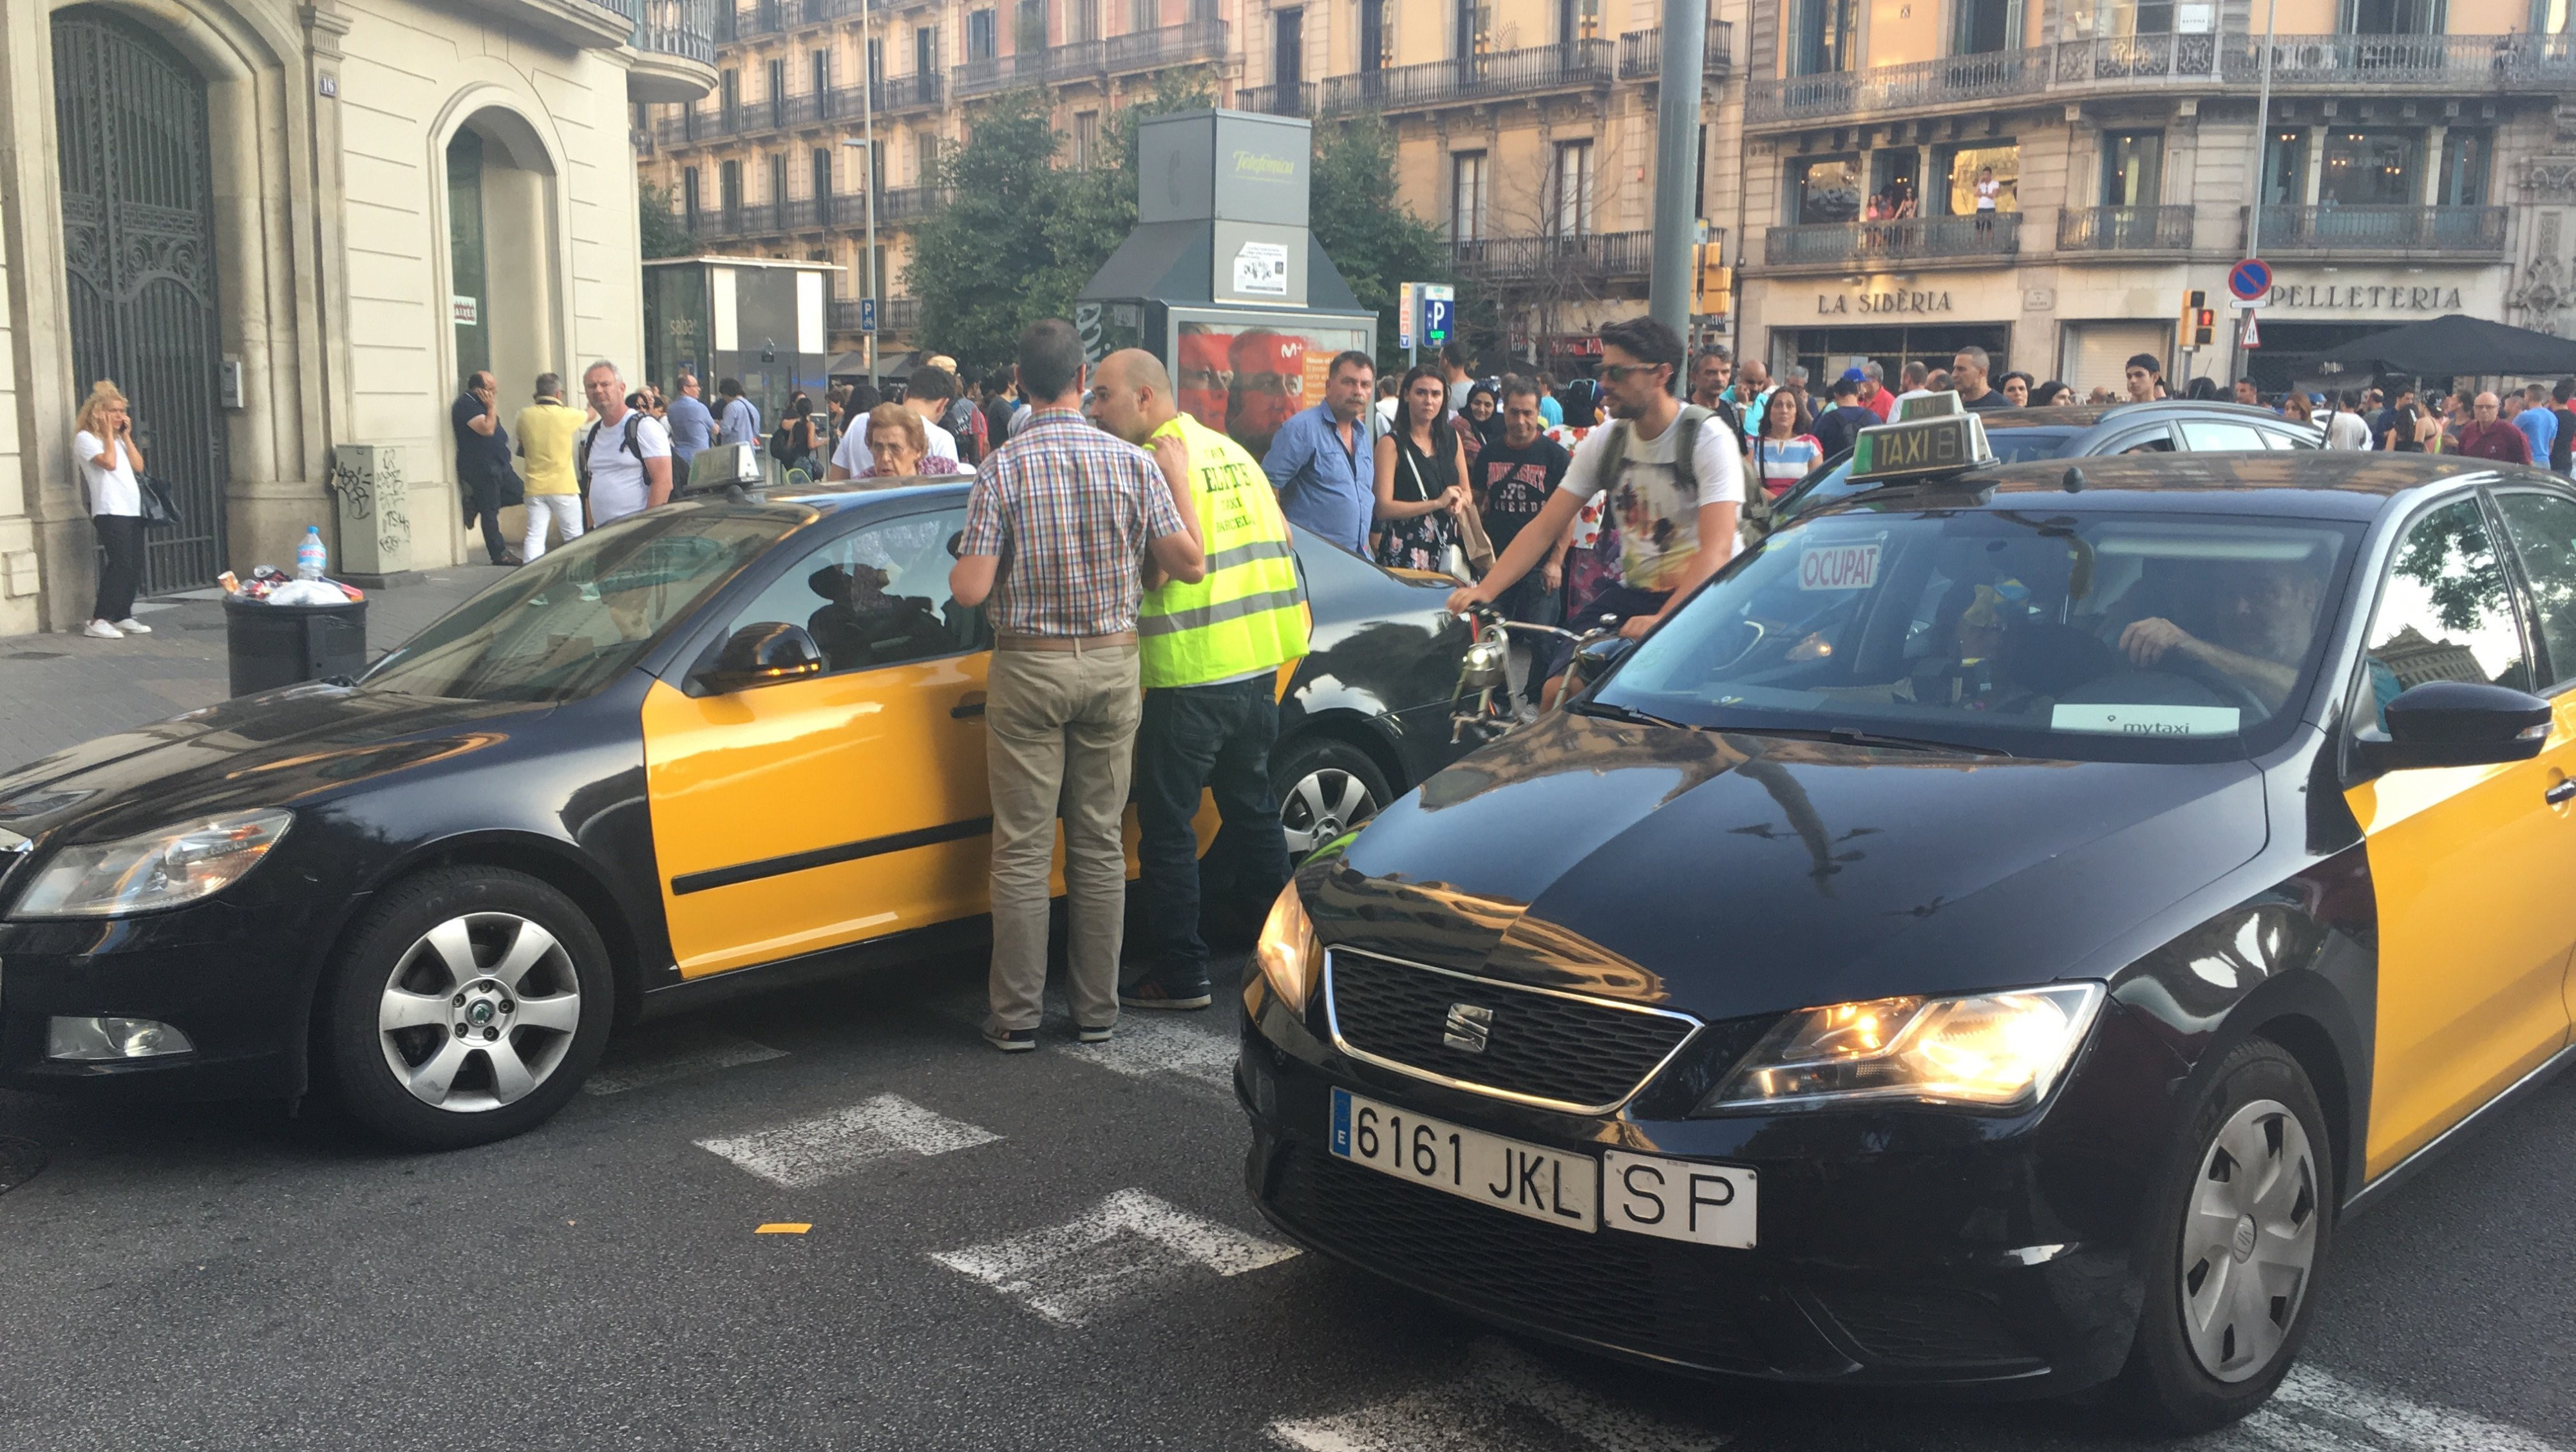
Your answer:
[1087,348,1309,1009]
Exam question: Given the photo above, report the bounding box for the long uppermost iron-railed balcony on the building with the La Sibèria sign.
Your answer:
[1744,31,2576,126]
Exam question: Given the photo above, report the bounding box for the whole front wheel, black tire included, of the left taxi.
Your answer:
[322,867,616,1151]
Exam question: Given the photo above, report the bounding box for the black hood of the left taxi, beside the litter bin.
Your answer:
[0,685,551,842]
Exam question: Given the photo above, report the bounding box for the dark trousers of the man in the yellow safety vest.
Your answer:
[1136,672,1288,983]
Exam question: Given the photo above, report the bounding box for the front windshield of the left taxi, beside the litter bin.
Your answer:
[358,505,814,701]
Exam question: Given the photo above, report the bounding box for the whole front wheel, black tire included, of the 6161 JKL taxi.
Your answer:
[2117,1037,2336,1434]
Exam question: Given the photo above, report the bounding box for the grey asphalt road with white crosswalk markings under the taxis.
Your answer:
[0,963,2576,1452]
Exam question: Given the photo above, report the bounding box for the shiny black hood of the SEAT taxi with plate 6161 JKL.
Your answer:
[1306,713,2264,1017]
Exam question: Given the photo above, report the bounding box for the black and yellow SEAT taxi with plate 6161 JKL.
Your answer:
[1236,409,2576,1429]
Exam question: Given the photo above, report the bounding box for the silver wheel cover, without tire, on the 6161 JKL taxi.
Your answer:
[2179,1099,2321,1382]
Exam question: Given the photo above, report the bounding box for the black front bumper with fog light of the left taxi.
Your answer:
[0,883,353,1099]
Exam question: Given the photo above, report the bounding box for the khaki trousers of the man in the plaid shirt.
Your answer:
[984,644,1144,1030]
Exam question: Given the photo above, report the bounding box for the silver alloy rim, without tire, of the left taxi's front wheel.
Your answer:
[376,911,582,1115]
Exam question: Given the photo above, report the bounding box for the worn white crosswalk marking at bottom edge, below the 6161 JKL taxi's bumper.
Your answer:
[1270,1339,1726,1452]
